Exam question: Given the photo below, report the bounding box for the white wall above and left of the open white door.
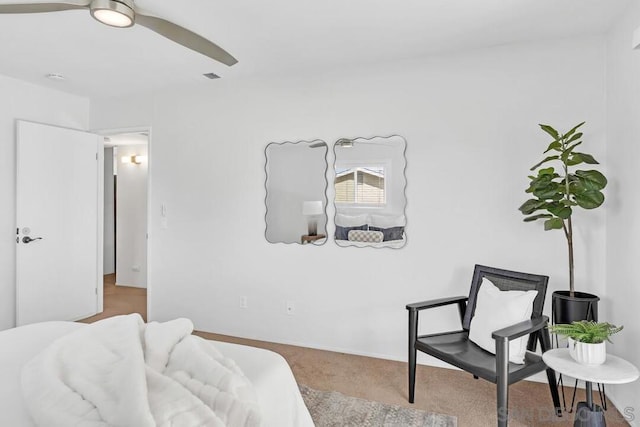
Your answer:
[0,75,89,329]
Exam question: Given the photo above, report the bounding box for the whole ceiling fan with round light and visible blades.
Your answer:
[0,0,238,66]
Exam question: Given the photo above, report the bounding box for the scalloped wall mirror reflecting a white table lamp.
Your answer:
[265,140,328,245]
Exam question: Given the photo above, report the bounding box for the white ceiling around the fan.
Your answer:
[0,0,637,97]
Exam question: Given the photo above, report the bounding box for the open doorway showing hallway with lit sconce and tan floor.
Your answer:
[103,131,149,320]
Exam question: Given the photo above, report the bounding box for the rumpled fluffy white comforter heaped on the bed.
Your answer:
[22,314,260,427]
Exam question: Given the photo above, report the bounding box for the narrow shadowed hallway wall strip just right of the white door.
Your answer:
[102,147,116,274]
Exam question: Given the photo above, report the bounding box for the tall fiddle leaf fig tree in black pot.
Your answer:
[519,122,607,324]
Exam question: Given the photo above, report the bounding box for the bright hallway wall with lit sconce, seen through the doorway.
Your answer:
[116,144,149,288]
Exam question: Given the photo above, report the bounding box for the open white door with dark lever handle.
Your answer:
[16,121,103,326]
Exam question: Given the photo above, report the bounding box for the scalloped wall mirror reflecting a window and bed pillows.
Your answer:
[333,135,407,249]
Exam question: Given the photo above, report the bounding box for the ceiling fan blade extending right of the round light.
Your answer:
[136,11,238,66]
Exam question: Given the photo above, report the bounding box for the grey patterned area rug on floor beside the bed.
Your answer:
[299,384,458,427]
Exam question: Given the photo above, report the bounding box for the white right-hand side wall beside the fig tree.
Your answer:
[602,2,640,425]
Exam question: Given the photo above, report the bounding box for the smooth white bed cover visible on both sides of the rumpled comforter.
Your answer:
[0,322,313,427]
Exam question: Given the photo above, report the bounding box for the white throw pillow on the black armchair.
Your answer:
[469,278,538,365]
